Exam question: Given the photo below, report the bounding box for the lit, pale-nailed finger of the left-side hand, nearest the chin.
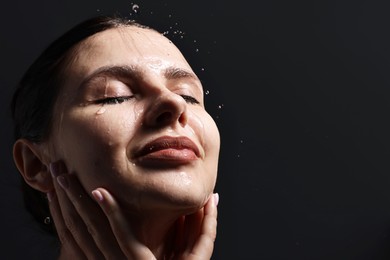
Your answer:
[92,188,155,259]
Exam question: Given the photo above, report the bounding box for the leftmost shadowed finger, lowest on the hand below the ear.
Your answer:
[47,191,85,259]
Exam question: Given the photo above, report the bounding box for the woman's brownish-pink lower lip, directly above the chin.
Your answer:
[138,149,198,166]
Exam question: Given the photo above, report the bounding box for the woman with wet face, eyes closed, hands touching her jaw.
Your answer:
[12,17,220,259]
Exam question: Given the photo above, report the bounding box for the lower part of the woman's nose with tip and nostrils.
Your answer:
[144,91,188,127]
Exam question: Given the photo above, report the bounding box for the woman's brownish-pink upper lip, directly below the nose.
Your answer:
[135,136,200,158]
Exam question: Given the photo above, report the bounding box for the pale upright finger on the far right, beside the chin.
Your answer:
[190,193,219,259]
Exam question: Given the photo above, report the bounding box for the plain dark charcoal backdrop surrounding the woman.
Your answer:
[0,0,390,260]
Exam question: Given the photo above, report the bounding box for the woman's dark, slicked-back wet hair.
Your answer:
[11,16,149,234]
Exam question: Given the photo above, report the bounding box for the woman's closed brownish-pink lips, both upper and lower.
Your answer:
[134,136,200,166]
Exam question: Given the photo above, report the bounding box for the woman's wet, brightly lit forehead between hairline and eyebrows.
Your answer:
[66,26,191,77]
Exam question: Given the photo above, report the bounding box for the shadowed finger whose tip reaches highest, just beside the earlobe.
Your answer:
[50,162,103,259]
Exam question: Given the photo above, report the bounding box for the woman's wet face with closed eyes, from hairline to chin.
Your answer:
[49,26,220,212]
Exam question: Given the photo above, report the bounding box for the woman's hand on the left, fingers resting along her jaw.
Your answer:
[48,162,155,259]
